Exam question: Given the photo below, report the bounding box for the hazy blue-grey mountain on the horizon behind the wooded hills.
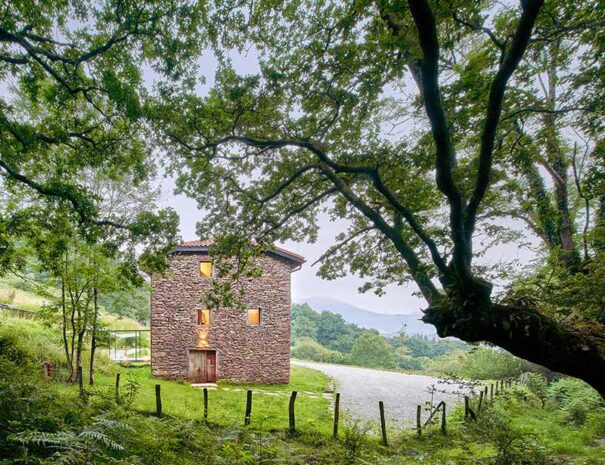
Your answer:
[304,297,437,337]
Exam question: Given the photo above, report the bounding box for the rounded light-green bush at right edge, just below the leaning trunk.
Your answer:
[546,378,605,425]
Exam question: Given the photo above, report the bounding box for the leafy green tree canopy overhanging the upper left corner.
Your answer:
[0,0,205,271]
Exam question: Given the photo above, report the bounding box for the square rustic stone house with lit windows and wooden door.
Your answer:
[150,241,305,384]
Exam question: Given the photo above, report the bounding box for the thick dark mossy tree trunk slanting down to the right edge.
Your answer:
[423,301,605,398]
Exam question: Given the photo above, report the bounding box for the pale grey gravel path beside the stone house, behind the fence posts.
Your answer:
[292,360,460,426]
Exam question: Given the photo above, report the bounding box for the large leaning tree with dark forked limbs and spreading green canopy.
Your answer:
[156,0,605,395]
